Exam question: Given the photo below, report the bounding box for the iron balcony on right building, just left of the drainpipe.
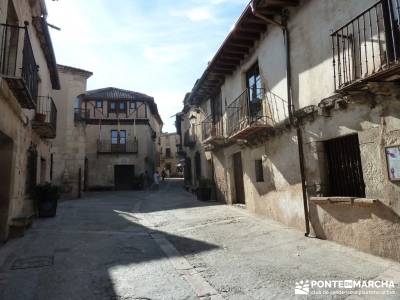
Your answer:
[226,88,288,139]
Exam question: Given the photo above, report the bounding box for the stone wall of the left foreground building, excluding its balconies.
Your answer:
[0,0,53,241]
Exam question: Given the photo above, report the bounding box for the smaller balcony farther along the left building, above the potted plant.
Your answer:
[32,96,57,139]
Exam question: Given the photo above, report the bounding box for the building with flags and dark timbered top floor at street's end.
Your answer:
[75,88,163,189]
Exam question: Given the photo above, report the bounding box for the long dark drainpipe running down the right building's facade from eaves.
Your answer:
[250,0,310,236]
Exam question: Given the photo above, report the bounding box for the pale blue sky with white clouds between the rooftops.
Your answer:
[47,0,248,132]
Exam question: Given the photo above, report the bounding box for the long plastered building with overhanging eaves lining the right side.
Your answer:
[177,0,400,260]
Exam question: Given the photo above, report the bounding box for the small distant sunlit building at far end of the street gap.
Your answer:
[159,132,183,177]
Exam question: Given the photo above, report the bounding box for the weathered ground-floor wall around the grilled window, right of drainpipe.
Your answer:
[304,96,400,260]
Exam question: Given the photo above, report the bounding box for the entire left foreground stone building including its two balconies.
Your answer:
[0,0,60,241]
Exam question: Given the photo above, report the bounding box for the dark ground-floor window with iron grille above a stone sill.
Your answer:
[324,134,365,197]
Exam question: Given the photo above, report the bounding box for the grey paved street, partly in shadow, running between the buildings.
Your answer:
[0,179,400,300]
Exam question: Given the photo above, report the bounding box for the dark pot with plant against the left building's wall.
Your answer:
[32,182,60,218]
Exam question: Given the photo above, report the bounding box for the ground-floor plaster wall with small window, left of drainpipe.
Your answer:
[214,131,304,229]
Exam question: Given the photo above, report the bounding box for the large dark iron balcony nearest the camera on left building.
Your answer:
[0,22,38,109]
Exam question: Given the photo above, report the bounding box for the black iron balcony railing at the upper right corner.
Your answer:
[331,0,400,90]
